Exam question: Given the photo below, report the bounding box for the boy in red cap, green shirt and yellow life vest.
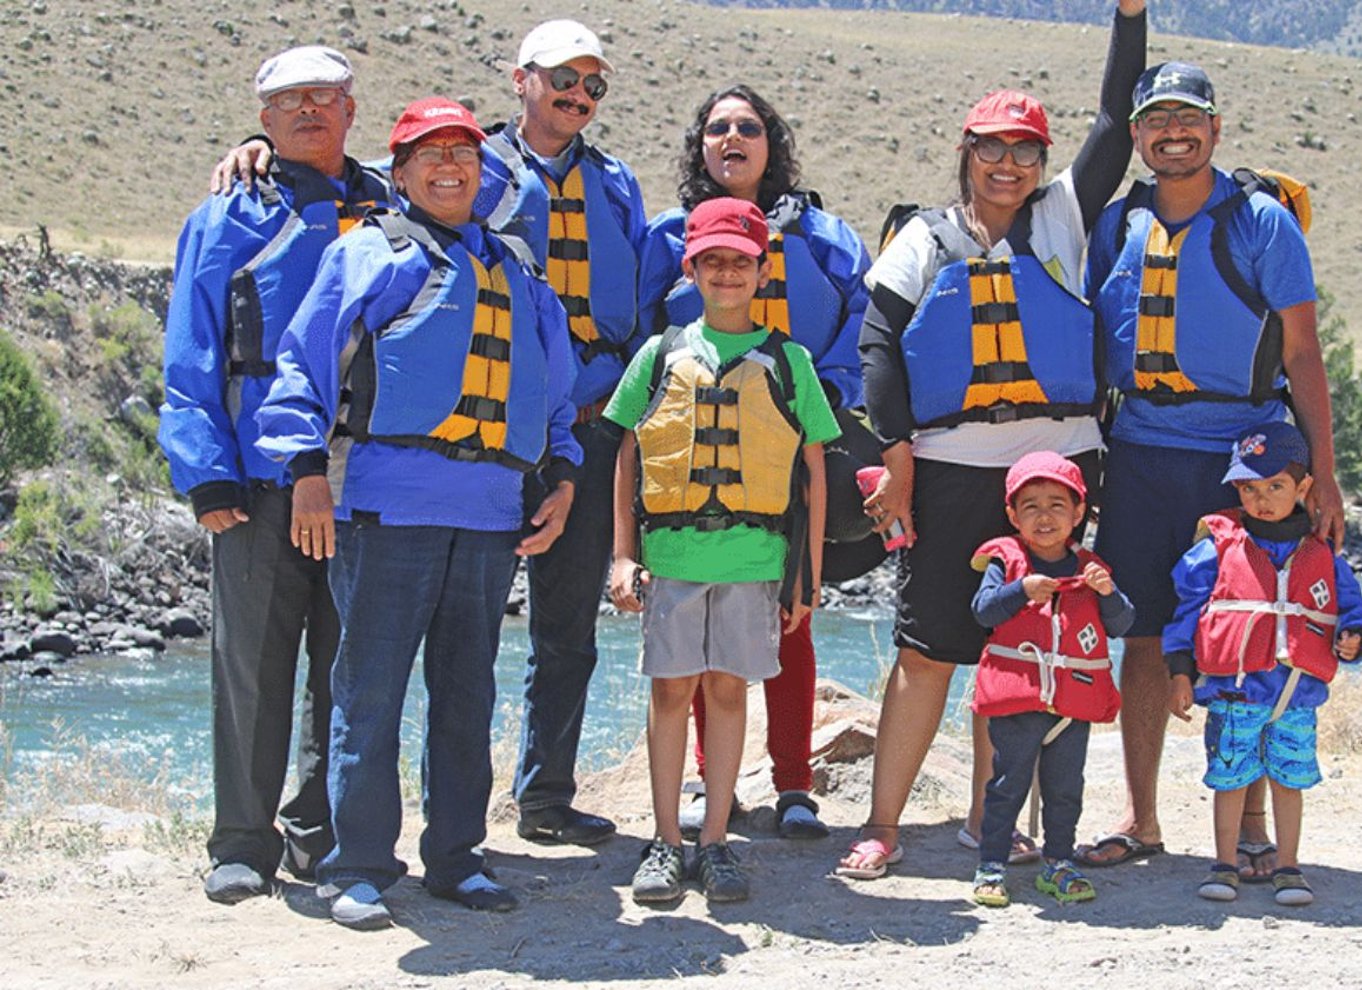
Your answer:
[605,197,840,901]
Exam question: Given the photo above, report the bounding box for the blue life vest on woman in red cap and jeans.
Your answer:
[336,212,549,471]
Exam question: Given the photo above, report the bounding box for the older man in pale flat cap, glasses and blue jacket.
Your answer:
[159,46,390,904]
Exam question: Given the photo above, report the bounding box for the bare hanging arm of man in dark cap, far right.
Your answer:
[1282,302,1344,552]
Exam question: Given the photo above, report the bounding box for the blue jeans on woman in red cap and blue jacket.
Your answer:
[317,523,520,889]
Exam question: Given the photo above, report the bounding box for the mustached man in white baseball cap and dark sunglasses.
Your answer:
[482,20,647,846]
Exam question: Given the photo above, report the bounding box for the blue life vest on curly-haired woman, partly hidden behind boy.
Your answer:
[663,195,846,361]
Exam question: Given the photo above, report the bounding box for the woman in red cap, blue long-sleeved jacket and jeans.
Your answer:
[257,98,582,929]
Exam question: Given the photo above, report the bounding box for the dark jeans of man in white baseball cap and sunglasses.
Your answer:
[515,419,620,810]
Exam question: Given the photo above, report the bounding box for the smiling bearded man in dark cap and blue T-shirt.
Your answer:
[1079,61,1343,878]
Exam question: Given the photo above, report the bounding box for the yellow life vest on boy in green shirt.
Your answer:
[635,324,804,531]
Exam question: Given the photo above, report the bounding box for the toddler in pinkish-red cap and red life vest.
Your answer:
[972,451,1135,907]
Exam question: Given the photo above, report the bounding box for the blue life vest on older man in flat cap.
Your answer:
[226,161,391,379]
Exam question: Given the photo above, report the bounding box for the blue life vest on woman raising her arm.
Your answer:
[900,210,1099,429]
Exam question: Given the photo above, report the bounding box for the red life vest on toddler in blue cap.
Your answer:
[1196,509,1339,684]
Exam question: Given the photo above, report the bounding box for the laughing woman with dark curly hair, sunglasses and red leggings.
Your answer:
[639,84,870,839]
